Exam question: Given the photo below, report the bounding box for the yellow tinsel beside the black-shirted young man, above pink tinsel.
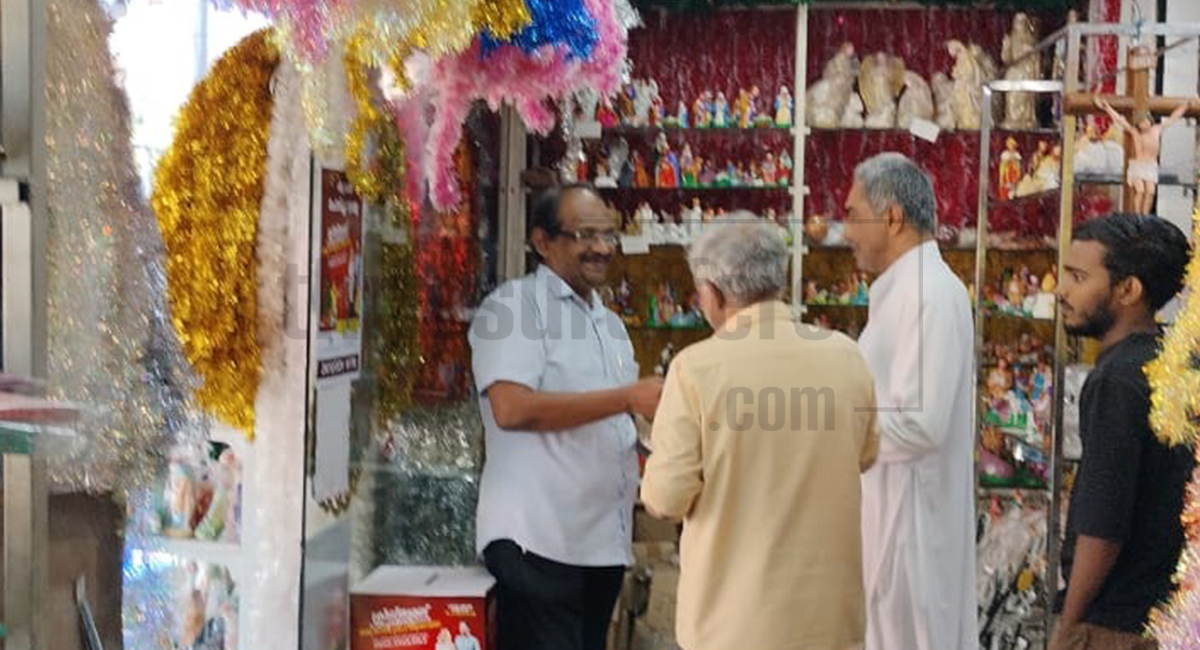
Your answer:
[1146,206,1200,446]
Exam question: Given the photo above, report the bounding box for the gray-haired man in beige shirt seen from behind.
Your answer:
[641,222,877,650]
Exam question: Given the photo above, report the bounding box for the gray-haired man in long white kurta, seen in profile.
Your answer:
[846,154,978,650]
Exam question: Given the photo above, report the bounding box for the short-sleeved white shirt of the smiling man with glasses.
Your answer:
[469,265,637,566]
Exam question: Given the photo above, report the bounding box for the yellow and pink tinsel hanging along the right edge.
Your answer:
[1146,196,1200,650]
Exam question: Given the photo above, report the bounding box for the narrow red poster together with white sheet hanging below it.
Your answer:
[312,164,364,502]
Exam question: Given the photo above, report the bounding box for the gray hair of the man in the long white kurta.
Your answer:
[854,151,937,234]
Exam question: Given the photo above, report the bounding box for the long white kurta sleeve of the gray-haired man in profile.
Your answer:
[878,296,972,463]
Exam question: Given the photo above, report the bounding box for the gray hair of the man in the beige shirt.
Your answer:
[688,218,790,302]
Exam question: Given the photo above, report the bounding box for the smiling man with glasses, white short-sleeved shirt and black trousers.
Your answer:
[469,186,661,650]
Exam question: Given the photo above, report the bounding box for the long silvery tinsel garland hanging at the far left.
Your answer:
[43,0,206,496]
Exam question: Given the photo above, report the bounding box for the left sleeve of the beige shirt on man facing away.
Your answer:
[642,356,704,519]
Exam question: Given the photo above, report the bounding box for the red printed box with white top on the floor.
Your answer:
[350,566,496,650]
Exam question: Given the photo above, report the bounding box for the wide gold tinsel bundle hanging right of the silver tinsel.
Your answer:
[151,30,280,437]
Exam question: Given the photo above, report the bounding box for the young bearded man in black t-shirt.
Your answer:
[1050,215,1194,650]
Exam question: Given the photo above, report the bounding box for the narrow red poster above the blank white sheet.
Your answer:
[320,169,362,333]
